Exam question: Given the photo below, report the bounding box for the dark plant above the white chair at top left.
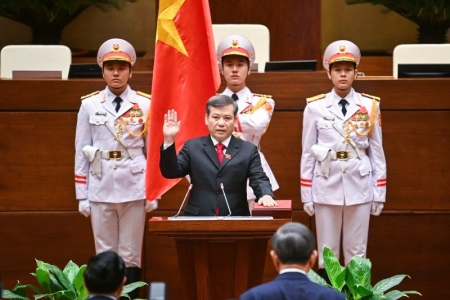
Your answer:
[0,0,137,45]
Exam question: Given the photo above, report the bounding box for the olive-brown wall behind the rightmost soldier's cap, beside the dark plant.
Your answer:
[321,0,417,51]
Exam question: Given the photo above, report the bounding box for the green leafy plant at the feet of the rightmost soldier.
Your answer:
[308,247,422,300]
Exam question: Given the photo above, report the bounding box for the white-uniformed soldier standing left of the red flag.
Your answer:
[75,39,158,299]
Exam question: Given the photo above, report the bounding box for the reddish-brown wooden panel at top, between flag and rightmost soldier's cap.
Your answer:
[209,0,321,60]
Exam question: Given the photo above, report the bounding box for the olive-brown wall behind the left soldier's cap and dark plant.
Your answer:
[0,0,156,56]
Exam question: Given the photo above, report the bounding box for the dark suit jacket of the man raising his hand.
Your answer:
[159,135,273,216]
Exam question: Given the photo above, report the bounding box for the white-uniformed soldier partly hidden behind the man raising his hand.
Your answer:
[217,35,279,212]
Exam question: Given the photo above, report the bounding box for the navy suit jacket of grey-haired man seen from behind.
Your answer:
[240,272,345,300]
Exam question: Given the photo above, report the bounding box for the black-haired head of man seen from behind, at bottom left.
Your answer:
[83,251,127,300]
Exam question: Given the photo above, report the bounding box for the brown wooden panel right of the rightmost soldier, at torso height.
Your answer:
[382,110,450,211]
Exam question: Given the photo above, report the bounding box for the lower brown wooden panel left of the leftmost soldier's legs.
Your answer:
[0,212,95,295]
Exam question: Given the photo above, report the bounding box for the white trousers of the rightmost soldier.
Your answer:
[314,202,372,269]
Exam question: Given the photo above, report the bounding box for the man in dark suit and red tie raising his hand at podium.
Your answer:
[160,95,277,216]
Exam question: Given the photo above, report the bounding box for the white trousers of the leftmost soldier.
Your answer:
[91,199,146,268]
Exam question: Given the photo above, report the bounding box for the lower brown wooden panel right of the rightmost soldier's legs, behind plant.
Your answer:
[367,214,450,299]
